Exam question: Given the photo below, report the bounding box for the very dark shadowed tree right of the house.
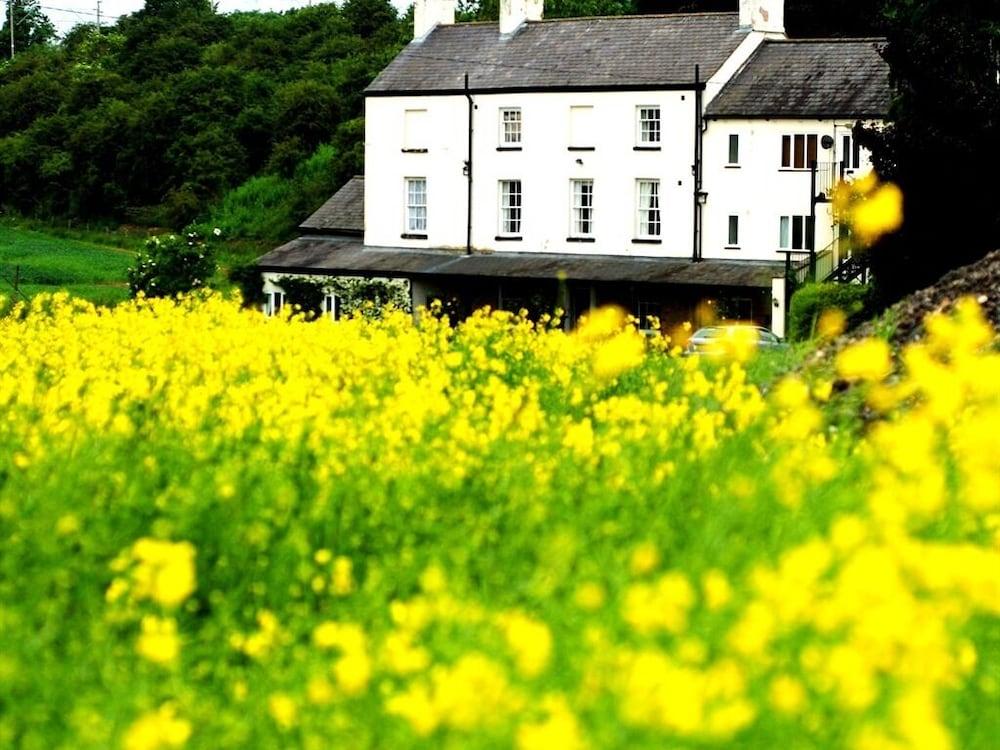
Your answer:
[867,0,1000,302]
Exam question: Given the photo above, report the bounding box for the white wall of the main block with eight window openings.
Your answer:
[365,91,694,257]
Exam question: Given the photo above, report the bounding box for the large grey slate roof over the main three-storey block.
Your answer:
[365,13,747,96]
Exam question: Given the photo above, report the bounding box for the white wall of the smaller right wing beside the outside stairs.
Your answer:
[702,120,871,260]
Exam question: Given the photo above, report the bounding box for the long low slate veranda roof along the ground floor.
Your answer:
[257,236,785,289]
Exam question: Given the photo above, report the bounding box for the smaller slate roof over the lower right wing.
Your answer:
[706,38,891,120]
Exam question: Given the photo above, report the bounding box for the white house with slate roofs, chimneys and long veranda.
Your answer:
[258,0,890,335]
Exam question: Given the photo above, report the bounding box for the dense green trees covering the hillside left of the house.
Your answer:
[0,0,409,228]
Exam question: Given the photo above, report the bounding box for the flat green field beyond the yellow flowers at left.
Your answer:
[0,224,134,305]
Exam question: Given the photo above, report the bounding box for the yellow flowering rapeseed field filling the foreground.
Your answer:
[0,296,1000,750]
